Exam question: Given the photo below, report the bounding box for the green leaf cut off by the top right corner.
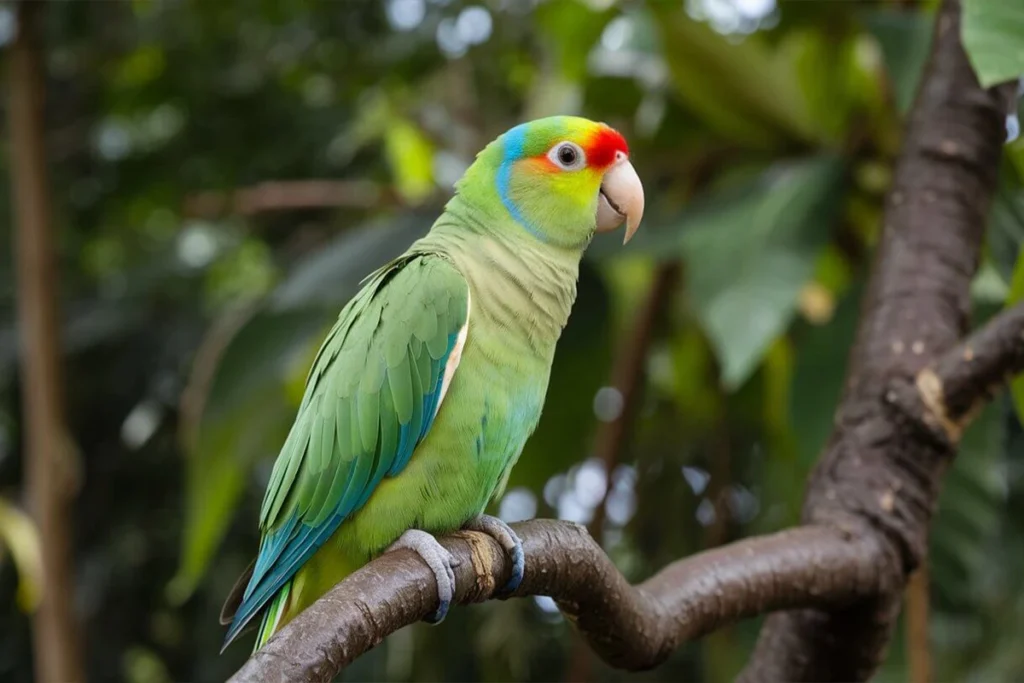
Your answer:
[961,0,1024,88]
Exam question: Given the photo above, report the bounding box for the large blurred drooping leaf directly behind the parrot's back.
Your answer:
[169,214,430,601]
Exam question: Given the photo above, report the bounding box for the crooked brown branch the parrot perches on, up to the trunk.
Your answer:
[231,520,894,683]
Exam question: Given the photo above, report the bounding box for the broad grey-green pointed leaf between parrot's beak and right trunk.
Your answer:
[618,157,844,390]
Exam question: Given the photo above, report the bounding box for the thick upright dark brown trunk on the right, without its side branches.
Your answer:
[741,0,1014,681]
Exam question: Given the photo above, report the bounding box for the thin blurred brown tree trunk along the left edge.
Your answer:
[8,1,83,682]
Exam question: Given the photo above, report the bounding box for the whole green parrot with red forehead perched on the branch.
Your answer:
[221,116,644,649]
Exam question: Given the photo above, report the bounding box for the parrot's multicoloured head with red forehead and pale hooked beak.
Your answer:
[459,116,644,248]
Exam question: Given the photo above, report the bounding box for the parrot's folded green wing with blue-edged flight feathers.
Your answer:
[225,254,470,645]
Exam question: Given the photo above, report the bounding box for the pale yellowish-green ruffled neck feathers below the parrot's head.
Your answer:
[411,196,582,354]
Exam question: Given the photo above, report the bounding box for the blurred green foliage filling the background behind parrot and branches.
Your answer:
[0,0,1024,682]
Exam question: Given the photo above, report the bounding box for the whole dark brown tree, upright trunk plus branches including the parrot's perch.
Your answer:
[232,0,1024,682]
